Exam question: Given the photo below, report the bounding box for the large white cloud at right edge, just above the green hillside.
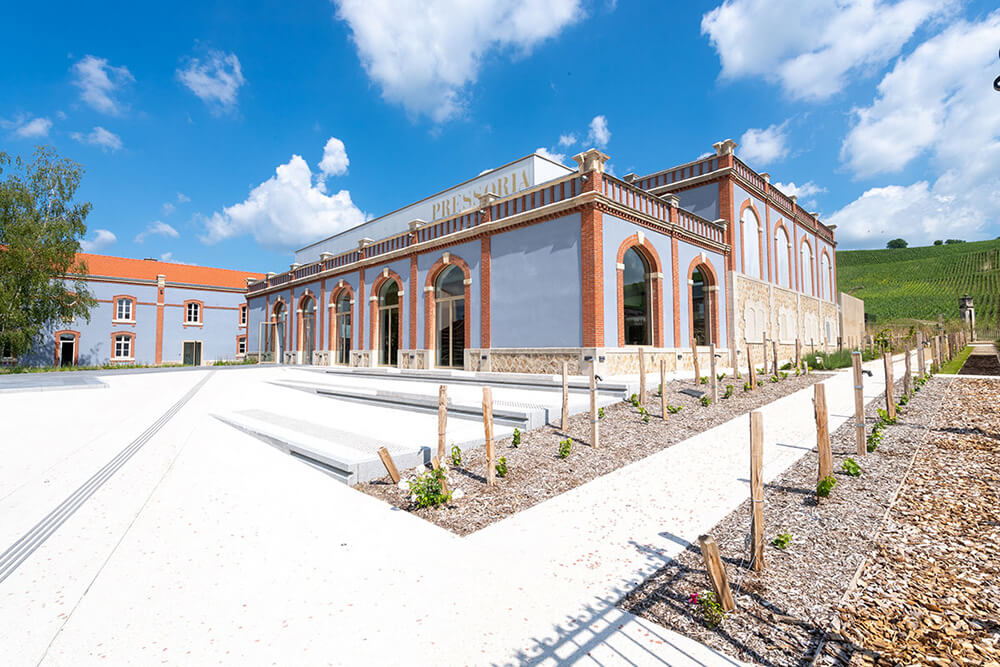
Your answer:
[829,11,1000,245]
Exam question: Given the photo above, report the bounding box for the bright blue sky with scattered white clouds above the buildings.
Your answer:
[0,0,1000,271]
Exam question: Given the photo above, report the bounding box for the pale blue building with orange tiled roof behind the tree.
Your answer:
[10,253,264,366]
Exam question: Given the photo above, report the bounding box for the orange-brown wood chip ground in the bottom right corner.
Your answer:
[823,380,1000,667]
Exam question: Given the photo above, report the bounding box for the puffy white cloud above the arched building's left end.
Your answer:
[201,145,366,251]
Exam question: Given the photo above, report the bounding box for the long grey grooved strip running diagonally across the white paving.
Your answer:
[0,371,214,583]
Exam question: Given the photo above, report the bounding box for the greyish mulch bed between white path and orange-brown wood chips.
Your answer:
[620,380,947,665]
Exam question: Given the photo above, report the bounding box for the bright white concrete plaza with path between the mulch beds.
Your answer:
[0,352,902,665]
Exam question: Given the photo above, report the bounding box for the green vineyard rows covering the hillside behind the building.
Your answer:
[837,240,1000,337]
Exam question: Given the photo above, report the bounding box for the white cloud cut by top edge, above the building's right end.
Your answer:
[701,0,956,101]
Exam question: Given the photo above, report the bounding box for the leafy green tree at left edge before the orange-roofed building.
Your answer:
[0,146,94,357]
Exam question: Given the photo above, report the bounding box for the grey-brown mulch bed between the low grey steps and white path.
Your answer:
[354,373,827,535]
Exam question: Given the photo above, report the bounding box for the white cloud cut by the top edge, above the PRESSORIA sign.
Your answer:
[334,0,583,123]
